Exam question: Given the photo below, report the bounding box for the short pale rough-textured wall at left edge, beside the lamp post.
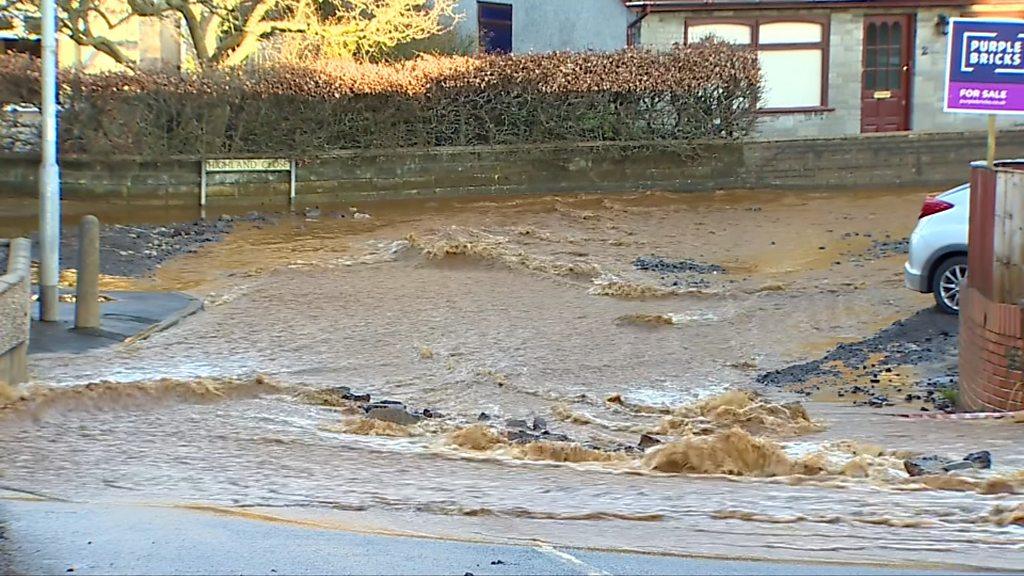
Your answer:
[0,238,32,384]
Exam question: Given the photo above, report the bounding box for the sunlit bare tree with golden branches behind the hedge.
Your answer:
[0,0,458,69]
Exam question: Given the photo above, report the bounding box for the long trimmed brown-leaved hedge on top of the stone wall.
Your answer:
[0,42,760,157]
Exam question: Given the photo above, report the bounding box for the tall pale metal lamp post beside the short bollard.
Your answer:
[39,0,60,322]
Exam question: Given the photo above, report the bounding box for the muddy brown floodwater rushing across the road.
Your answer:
[0,191,1024,569]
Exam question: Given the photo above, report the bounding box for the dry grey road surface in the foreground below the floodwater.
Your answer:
[0,492,983,575]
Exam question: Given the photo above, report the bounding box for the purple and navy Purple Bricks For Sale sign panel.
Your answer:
[945,18,1024,114]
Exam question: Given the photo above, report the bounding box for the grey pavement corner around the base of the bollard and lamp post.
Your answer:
[29,290,203,356]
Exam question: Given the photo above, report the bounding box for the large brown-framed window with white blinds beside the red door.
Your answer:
[686,19,828,111]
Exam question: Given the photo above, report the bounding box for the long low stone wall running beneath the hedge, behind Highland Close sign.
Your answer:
[0,131,1024,205]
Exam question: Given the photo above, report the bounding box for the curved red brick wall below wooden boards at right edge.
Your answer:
[959,287,1024,412]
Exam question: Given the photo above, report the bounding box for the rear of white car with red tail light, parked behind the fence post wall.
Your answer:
[903,184,971,314]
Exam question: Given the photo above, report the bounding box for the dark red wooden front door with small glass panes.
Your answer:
[860,14,913,132]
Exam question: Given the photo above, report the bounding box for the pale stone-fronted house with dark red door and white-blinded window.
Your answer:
[625,0,1024,137]
